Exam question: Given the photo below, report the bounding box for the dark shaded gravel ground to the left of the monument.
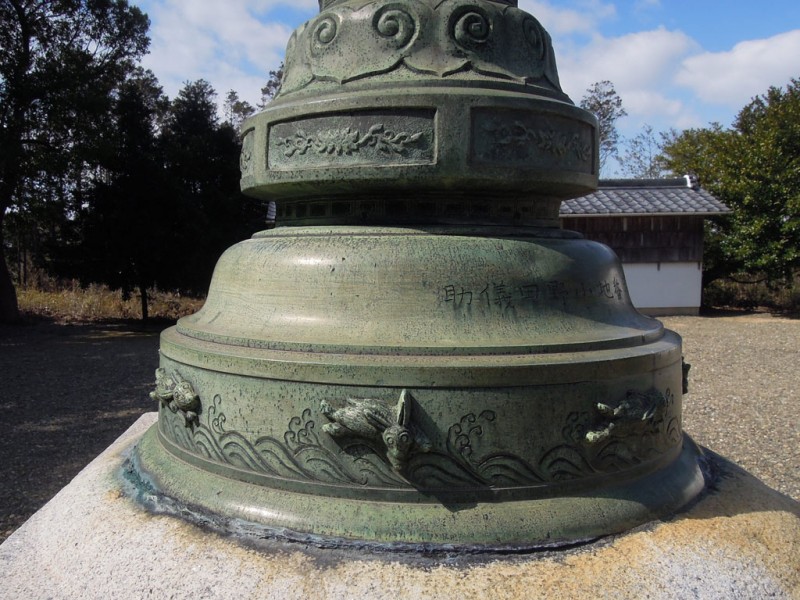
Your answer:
[0,320,166,541]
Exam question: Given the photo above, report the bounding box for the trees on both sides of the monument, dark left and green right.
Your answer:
[0,0,800,322]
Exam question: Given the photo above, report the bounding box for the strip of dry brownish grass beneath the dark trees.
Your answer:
[17,281,203,323]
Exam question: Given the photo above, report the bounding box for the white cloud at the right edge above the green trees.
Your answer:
[676,29,800,108]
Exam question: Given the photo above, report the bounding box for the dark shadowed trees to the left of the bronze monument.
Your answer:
[0,0,280,322]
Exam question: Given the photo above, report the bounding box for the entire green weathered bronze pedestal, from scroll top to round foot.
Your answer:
[136,0,703,550]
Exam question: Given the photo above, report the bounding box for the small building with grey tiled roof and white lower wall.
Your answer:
[561,176,730,315]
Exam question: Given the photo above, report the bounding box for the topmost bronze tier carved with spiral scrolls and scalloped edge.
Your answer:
[281,0,561,95]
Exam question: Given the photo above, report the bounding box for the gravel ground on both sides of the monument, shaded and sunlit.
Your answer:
[0,314,800,541]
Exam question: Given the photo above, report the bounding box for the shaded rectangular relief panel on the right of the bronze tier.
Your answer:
[471,108,594,174]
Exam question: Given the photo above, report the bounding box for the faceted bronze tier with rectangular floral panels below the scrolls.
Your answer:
[241,89,597,206]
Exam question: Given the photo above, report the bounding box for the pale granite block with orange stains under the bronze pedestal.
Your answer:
[0,414,800,600]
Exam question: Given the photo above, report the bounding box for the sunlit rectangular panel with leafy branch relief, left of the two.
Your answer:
[267,110,435,170]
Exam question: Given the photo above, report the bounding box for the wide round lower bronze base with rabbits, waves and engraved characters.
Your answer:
[137,226,704,550]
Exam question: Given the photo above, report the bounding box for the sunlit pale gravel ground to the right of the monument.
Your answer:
[661,314,800,501]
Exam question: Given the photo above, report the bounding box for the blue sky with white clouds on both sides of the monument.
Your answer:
[132,0,800,151]
